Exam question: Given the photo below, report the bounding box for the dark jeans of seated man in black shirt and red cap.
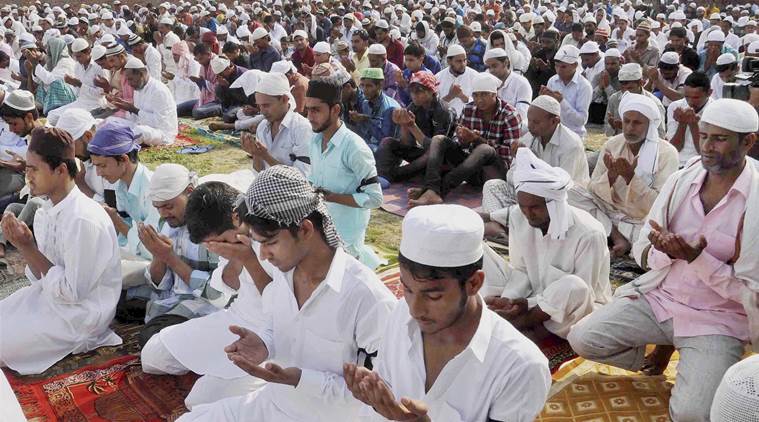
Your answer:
[374,138,430,182]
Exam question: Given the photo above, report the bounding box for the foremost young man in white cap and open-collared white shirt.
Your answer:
[343,205,551,422]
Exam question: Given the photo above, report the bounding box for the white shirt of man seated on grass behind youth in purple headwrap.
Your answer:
[128,78,179,143]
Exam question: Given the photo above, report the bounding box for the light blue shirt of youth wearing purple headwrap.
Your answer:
[115,164,159,259]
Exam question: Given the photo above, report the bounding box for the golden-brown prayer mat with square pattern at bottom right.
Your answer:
[536,373,672,422]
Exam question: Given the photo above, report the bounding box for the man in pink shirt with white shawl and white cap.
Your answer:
[568,99,759,421]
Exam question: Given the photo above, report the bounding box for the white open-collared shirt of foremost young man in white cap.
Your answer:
[364,297,551,422]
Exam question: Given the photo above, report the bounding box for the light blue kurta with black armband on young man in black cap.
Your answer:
[309,123,382,269]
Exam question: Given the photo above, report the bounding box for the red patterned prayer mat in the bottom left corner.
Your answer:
[5,355,198,422]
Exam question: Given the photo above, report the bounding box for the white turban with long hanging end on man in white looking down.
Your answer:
[514,148,572,240]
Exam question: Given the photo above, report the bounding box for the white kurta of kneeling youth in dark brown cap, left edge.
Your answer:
[0,187,121,374]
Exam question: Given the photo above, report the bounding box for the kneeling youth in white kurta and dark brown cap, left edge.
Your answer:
[0,128,121,375]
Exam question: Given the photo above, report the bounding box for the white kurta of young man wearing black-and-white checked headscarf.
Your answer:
[179,249,397,422]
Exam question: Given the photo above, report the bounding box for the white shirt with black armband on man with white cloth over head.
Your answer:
[256,110,314,177]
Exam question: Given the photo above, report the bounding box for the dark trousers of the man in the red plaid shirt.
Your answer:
[424,136,506,197]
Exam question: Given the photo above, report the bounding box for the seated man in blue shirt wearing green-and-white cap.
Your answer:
[350,67,401,152]
